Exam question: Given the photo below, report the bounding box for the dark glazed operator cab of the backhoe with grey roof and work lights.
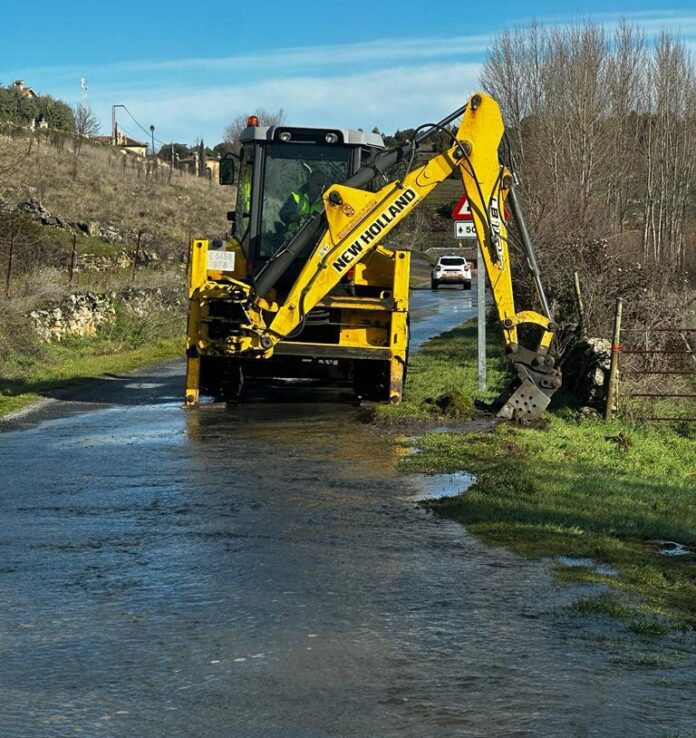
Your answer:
[226,119,384,279]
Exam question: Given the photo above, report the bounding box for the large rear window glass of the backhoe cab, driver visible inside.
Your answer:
[254,142,352,263]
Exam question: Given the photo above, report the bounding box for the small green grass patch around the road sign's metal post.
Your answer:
[372,321,506,426]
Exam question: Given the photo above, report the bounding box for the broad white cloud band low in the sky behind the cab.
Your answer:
[87,63,480,143]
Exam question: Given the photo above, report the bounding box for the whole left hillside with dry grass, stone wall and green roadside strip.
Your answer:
[0,124,234,415]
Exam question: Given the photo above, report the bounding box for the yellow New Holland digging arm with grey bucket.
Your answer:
[194,93,561,418]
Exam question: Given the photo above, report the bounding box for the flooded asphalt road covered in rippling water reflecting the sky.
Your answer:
[0,290,696,738]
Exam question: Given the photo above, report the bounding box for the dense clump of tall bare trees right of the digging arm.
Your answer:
[482,22,696,340]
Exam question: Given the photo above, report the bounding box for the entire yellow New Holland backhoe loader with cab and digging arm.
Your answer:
[186,93,561,418]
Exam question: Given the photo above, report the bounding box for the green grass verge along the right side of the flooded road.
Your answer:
[392,316,696,635]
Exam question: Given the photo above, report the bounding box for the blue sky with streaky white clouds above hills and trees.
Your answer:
[0,0,696,145]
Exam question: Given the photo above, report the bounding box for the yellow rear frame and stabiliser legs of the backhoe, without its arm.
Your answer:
[186,240,411,405]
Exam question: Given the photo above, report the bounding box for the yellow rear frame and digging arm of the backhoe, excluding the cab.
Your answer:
[186,93,560,417]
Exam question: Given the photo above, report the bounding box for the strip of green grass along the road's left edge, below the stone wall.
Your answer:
[0,315,184,416]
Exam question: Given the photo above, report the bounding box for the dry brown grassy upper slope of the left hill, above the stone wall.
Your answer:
[0,125,231,255]
